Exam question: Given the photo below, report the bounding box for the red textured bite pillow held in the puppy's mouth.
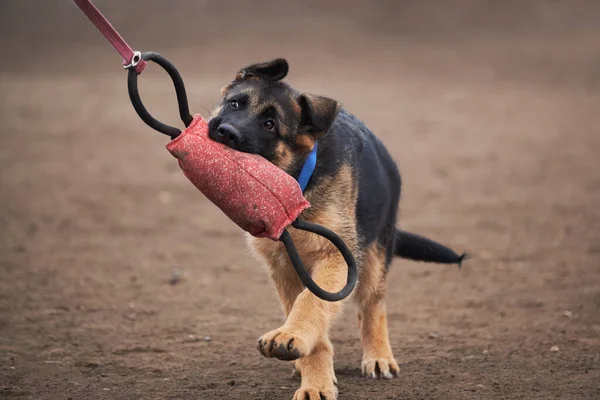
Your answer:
[167,115,310,240]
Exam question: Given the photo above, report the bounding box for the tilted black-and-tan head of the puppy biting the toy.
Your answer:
[209,58,339,171]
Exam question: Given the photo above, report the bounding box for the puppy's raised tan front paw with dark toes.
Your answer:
[257,327,310,361]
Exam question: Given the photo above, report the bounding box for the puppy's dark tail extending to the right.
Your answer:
[394,229,469,267]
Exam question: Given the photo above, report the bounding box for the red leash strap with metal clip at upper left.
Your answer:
[73,0,147,74]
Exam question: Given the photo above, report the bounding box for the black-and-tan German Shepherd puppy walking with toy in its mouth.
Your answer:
[209,59,464,400]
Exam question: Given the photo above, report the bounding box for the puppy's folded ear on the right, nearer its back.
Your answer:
[296,93,340,139]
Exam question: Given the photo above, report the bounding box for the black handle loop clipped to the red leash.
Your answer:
[127,52,192,139]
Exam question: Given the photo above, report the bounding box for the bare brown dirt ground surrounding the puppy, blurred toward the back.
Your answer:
[0,0,600,400]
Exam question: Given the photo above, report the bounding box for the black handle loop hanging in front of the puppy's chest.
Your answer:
[279,220,358,301]
